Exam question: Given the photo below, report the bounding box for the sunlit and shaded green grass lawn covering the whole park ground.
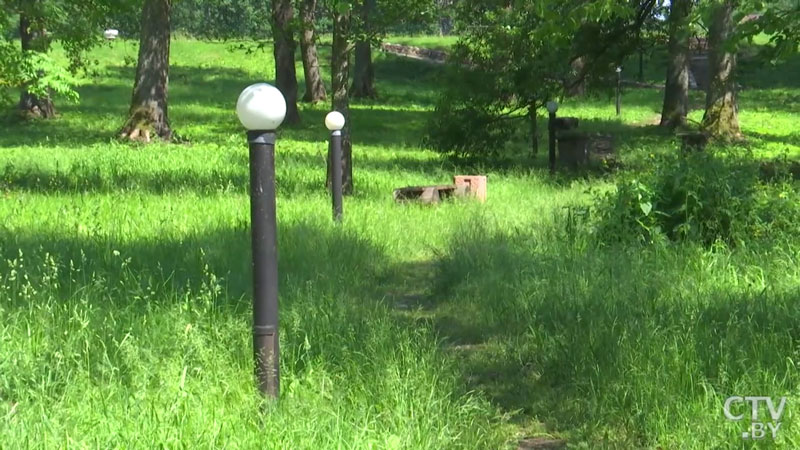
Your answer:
[0,37,800,449]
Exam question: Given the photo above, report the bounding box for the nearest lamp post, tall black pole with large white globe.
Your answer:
[236,83,286,399]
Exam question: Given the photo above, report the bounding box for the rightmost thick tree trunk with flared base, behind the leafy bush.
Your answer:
[703,0,741,139]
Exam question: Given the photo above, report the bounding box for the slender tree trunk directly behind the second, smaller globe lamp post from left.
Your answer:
[327,13,353,194]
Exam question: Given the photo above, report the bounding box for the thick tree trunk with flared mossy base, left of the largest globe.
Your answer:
[121,0,173,142]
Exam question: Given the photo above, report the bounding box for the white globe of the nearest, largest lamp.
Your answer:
[236,83,286,131]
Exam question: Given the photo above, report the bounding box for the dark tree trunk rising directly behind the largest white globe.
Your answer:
[272,0,300,124]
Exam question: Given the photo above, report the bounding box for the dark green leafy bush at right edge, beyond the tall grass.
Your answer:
[595,152,800,245]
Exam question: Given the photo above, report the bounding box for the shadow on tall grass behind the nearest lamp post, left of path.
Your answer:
[0,223,386,382]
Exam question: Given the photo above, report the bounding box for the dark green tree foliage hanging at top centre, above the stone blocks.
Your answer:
[428,0,654,156]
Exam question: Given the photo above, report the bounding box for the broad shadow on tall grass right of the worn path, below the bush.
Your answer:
[412,227,800,448]
